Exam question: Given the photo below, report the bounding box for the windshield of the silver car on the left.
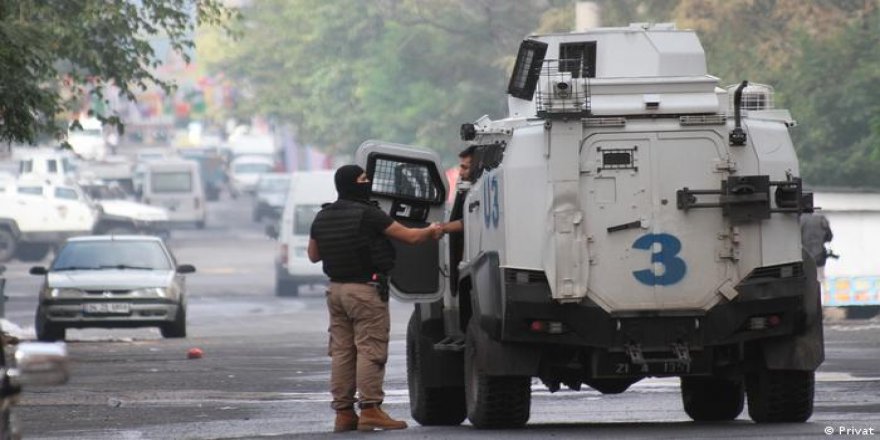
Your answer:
[51,240,171,271]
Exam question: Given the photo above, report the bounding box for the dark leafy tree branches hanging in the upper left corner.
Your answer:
[0,0,234,143]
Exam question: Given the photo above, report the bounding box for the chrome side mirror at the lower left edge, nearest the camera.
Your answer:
[9,342,70,385]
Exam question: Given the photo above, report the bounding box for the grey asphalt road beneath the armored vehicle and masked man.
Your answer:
[6,194,880,440]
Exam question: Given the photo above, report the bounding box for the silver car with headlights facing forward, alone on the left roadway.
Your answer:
[30,235,196,341]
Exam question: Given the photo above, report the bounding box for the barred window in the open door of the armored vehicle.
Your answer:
[367,157,445,204]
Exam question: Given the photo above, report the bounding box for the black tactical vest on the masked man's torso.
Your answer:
[312,200,394,282]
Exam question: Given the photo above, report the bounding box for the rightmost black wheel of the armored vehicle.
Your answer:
[746,370,816,423]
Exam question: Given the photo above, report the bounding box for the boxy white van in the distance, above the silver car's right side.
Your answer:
[142,160,207,229]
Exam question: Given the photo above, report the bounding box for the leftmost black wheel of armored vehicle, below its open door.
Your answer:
[406,310,467,426]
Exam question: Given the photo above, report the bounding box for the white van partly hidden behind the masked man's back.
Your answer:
[270,170,336,296]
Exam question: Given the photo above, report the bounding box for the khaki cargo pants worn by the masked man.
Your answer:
[327,283,390,409]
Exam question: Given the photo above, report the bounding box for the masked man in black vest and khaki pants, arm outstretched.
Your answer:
[308,165,443,432]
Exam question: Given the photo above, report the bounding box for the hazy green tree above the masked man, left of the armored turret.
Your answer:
[200,0,570,158]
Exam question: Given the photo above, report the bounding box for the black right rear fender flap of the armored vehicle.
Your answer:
[761,253,825,371]
